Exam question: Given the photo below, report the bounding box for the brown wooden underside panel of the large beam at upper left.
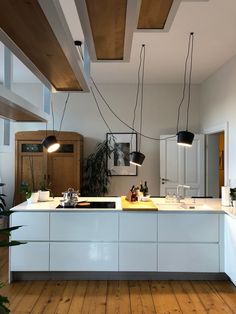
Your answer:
[0,0,82,91]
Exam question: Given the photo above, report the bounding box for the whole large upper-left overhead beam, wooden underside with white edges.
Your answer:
[0,0,89,91]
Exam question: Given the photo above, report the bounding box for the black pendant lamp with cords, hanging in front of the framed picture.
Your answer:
[130,44,145,167]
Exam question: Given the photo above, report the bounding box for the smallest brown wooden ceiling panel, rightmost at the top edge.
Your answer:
[137,0,173,29]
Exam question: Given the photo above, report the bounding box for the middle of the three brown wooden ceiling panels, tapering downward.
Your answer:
[86,0,127,60]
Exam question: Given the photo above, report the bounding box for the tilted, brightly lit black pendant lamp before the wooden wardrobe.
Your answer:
[42,93,70,153]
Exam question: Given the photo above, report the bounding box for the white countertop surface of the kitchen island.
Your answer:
[11,197,236,218]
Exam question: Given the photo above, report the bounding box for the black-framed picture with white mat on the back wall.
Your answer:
[107,133,137,176]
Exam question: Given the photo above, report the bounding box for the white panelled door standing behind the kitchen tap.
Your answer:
[160,134,205,196]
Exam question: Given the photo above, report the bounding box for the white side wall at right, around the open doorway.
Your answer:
[200,56,236,186]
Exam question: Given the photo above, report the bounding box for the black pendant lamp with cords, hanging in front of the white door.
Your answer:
[176,32,194,147]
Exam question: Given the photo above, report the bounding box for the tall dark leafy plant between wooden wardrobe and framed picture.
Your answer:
[81,140,114,196]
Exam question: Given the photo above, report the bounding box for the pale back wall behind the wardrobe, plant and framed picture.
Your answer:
[0,81,199,206]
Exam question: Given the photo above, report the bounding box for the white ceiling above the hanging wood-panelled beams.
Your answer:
[0,0,236,84]
